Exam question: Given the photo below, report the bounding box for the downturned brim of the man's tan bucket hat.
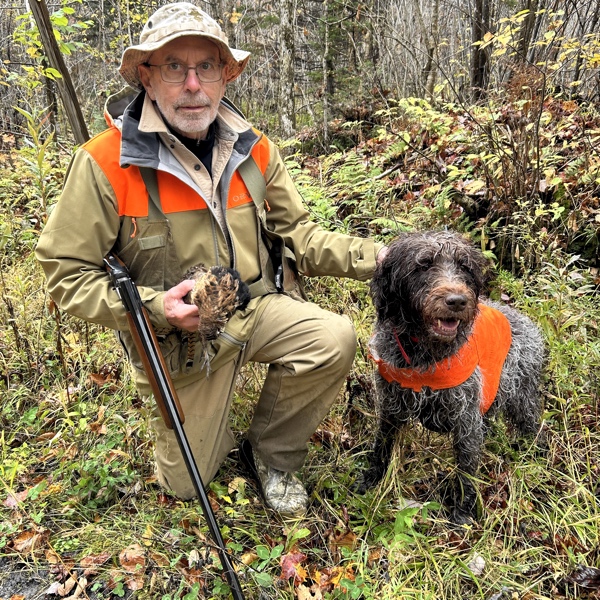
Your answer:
[119,30,250,90]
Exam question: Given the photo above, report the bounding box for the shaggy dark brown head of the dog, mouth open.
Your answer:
[371,232,487,343]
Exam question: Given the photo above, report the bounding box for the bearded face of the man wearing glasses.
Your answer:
[138,36,227,139]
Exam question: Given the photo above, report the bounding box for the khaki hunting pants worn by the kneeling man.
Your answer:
[153,294,356,499]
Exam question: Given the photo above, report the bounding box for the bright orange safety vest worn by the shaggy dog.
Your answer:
[371,304,512,415]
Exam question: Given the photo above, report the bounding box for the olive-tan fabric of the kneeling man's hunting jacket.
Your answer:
[36,92,381,389]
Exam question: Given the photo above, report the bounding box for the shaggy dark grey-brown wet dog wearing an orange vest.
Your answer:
[358,231,544,524]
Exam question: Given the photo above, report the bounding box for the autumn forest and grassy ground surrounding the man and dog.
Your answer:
[0,0,600,600]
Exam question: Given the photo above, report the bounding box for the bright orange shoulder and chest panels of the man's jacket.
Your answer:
[83,127,270,217]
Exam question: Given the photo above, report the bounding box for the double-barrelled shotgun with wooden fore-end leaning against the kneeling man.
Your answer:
[104,253,244,600]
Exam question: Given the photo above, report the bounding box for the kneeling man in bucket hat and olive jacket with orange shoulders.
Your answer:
[36,2,381,515]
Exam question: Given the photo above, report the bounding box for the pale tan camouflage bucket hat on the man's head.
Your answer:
[119,2,250,89]
